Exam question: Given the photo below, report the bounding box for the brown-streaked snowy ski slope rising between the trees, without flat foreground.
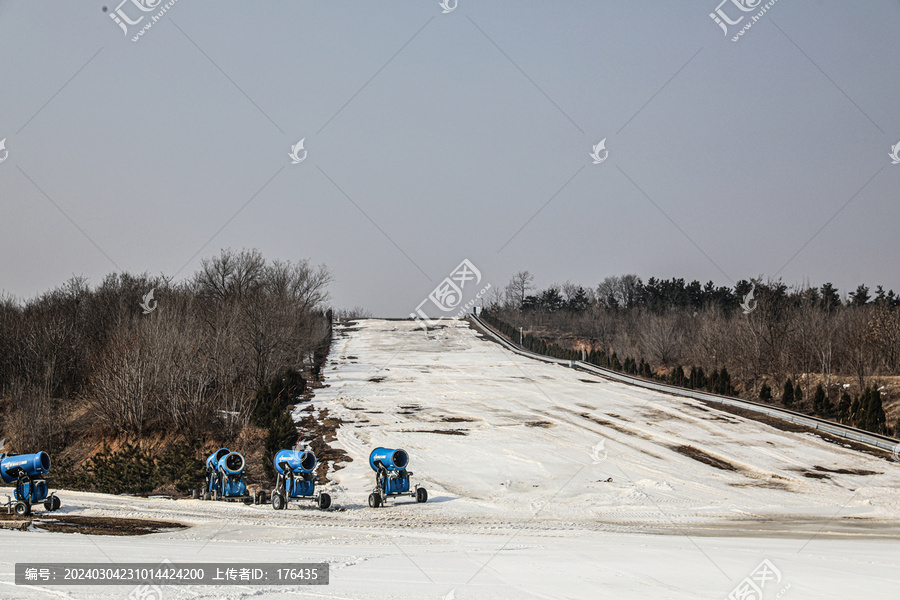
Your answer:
[316,321,900,533]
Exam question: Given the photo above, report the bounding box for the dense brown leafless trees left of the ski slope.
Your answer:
[0,250,331,451]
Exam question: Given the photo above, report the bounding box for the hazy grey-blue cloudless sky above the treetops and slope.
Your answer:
[0,0,900,316]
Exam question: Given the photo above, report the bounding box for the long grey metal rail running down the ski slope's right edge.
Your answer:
[470,315,900,452]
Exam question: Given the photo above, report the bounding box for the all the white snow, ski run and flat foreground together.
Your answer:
[0,320,900,600]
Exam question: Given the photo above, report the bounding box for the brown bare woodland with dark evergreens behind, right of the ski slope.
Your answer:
[486,271,900,408]
